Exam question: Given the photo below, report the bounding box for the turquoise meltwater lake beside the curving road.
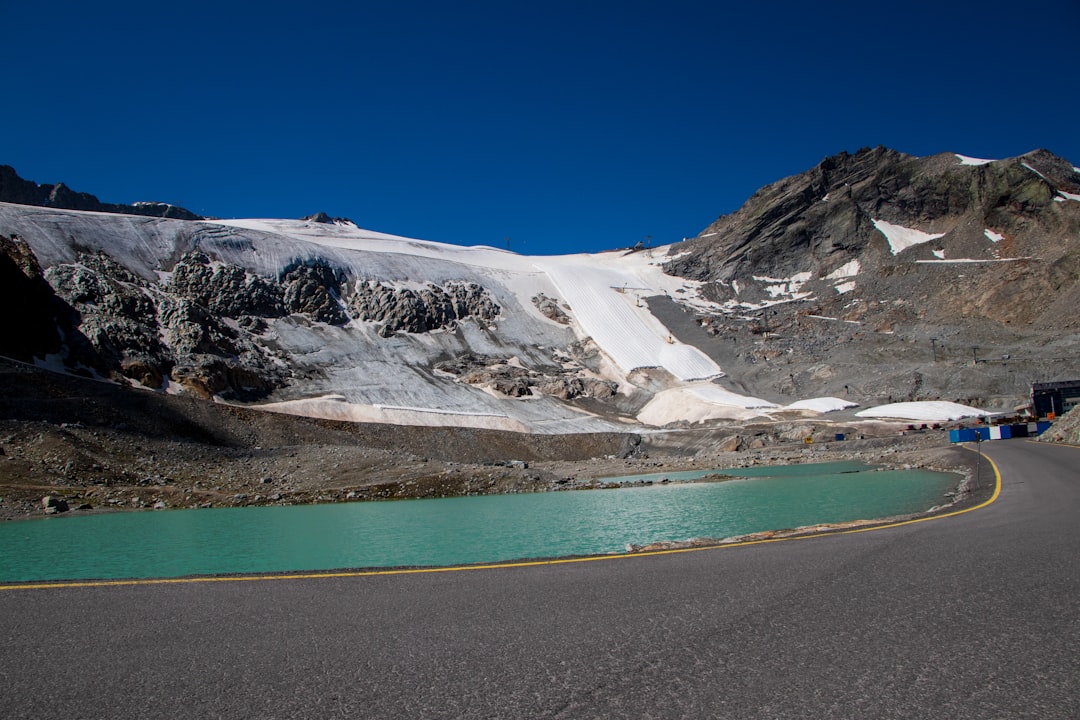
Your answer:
[0,462,960,582]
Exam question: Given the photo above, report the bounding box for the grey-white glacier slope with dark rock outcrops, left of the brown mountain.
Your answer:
[0,204,760,433]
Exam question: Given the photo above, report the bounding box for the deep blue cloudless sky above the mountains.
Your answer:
[0,0,1080,254]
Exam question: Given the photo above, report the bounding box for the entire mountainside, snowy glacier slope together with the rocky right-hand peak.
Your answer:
[0,148,1080,433]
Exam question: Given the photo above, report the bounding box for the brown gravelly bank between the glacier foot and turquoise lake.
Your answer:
[0,361,974,519]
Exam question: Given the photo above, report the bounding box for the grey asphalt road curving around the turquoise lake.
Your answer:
[0,440,1080,720]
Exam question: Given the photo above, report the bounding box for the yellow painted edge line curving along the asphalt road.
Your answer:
[0,448,1001,592]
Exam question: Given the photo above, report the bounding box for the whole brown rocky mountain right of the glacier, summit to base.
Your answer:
[662,147,1080,410]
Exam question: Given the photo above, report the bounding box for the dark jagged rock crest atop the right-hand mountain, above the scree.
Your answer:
[664,147,1080,291]
